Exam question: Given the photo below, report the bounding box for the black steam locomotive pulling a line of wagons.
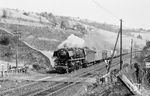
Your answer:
[53,48,120,73]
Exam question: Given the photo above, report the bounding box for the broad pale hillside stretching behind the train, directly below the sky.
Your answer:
[0,9,148,70]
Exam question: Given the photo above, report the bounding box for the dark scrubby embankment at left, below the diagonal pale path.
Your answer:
[0,29,52,72]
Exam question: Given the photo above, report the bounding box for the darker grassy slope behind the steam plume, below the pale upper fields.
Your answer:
[0,23,82,50]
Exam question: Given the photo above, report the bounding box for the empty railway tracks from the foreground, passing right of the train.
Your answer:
[0,53,138,96]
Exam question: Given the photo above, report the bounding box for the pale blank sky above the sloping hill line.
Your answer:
[0,0,150,29]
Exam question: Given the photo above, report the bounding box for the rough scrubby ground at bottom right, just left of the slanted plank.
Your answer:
[81,81,132,96]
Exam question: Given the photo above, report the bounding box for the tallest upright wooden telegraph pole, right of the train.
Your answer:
[120,19,123,70]
